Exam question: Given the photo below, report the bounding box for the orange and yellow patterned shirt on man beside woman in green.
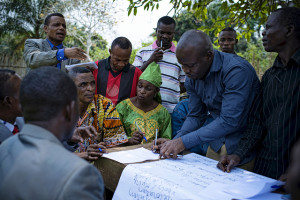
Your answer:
[77,94,128,152]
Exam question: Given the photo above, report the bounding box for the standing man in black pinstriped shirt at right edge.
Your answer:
[218,7,300,179]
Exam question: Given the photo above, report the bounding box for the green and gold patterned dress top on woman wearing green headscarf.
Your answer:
[117,99,172,143]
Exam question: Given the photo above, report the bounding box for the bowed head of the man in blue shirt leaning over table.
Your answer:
[176,30,214,79]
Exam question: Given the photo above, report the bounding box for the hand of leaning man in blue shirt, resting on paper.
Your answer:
[159,138,185,158]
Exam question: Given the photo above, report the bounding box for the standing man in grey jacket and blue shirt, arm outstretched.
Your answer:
[24,13,86,71]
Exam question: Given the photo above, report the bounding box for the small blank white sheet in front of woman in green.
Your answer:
[103,147,159,164]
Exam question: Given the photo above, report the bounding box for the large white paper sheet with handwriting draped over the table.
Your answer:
[113,153,282,200]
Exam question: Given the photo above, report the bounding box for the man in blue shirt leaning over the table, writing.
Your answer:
[156,30,260,166]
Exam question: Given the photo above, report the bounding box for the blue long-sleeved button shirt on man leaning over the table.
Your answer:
[175,50,260,154]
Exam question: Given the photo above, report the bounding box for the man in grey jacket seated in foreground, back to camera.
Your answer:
[0,67,104,200]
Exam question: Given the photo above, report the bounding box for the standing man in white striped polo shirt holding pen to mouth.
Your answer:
[133,16,185,113]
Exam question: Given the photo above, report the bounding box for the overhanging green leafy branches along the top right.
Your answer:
[128,0,300,41]
